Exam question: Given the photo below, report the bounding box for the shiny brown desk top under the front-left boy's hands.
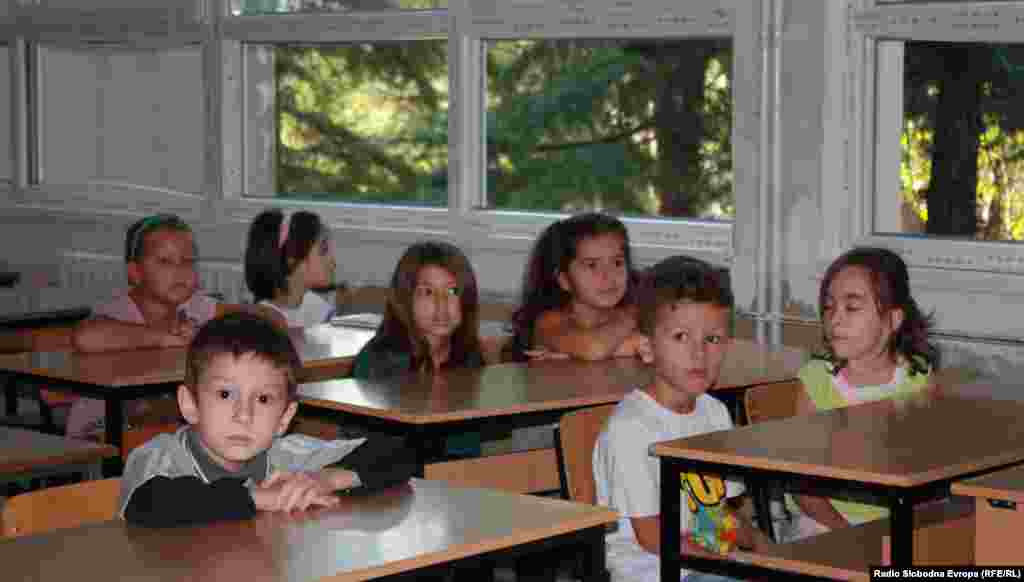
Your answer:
[0,480,616,582]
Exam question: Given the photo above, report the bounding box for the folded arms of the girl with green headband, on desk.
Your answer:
[72,318,196,351]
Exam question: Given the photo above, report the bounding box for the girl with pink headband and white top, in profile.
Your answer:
[246,210,336,327]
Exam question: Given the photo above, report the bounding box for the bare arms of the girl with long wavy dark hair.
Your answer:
[534,307,637,361]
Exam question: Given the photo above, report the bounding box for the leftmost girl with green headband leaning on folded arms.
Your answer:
[67,214,278,437]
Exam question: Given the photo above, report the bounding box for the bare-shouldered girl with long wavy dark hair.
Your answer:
[505,212,645,360]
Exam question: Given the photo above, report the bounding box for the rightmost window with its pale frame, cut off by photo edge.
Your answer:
[843,0,1024,276]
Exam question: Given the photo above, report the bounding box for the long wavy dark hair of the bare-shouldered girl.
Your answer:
[503,212,636,360]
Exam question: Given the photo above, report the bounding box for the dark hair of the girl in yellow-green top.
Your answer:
[818,247,939,376]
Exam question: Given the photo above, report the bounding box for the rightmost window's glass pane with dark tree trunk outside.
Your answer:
[874,41,1024,241]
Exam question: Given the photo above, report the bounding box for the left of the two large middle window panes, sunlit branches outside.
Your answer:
[246,40,449,206]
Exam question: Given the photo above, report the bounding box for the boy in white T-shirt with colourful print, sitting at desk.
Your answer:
[593,256,768,582]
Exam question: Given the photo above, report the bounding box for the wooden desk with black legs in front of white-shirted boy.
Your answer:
[654,398,1024,577]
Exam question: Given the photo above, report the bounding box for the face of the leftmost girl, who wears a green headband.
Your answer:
[128,228,199,307]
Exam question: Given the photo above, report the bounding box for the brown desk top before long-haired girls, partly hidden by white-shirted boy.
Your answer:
[299,340,803,424]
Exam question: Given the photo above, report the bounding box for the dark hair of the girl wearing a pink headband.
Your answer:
[246,209,327,301]
